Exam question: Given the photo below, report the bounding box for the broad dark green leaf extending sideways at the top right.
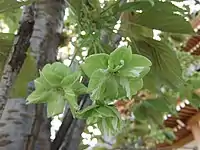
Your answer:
[135,2,194,34]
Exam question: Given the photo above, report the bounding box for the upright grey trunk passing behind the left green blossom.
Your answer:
[26,0,65,150]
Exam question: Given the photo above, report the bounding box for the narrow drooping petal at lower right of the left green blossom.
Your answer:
[64,88,79,116]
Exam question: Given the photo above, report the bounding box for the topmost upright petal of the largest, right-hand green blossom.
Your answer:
[108,46,132,72]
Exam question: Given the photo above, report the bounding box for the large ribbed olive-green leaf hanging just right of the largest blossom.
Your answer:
[133,38,184,89]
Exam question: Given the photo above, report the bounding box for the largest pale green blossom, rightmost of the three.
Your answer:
[81,47,151,102]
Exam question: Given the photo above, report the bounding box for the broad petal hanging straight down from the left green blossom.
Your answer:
[47,93,65,117]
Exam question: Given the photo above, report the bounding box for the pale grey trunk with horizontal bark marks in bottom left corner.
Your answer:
[0,98,35,150]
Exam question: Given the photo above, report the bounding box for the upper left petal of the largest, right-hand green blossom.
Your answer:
[81,53,109,77]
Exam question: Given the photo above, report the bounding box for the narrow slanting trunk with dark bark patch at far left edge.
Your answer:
[0,6,34,117]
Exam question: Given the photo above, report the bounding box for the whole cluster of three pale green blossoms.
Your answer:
[27,47,151,133]
